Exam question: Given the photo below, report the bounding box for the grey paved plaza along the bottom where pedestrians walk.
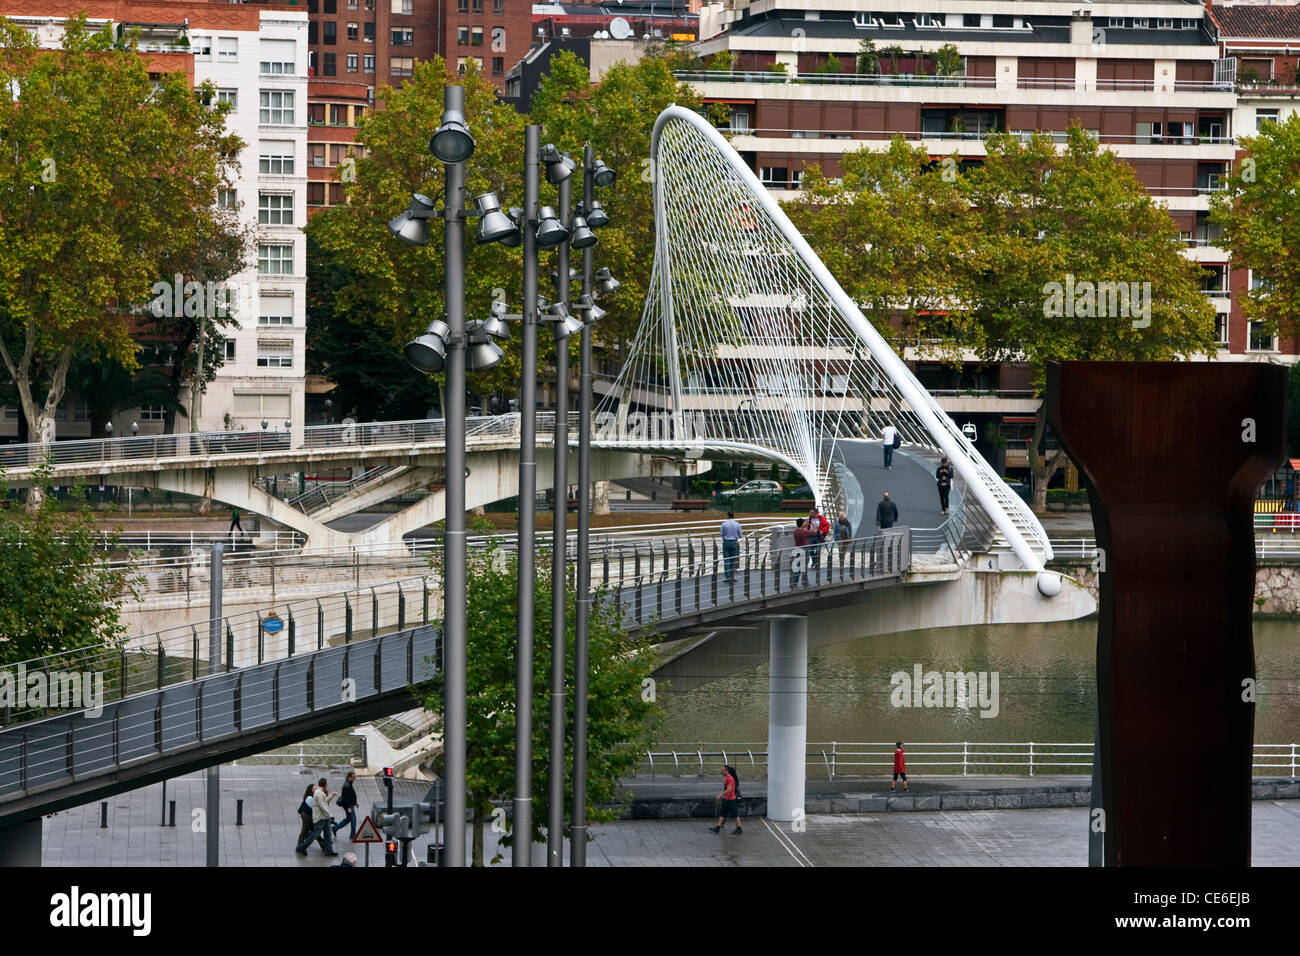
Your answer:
[44,766,1300,868]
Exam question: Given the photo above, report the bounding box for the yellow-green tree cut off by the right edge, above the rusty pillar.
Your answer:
[1210,113,1300,337]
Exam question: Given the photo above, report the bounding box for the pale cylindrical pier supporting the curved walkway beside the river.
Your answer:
[767,615,809,823]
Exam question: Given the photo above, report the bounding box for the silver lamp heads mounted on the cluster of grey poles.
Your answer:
[390,128,620,374]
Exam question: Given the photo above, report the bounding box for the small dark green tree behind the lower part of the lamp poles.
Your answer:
[425,550,659,866]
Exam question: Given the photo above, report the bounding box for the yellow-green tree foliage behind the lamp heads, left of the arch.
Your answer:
[307,49,697,407]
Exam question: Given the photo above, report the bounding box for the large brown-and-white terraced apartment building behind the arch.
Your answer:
[650,0,1300,476]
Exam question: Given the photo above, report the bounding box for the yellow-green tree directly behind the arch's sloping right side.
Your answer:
[785,137,979,360]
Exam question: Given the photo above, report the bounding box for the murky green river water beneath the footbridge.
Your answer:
[658,620,1300,745]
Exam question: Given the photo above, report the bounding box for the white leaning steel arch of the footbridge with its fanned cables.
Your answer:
[595,105,1052,580]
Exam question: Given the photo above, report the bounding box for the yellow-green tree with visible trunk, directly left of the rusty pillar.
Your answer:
[961,132,1216,511]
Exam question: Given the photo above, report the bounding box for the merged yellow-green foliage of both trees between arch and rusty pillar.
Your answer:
[793,128,1216,510]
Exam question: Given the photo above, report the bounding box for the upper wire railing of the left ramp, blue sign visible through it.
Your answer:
[0,572,441,726]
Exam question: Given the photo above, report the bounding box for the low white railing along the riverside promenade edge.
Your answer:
[636,740,1300,792]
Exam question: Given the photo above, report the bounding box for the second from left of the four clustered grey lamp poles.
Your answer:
[511,126,542,866]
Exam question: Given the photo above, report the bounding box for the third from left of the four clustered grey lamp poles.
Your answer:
[546,166,573,866]
